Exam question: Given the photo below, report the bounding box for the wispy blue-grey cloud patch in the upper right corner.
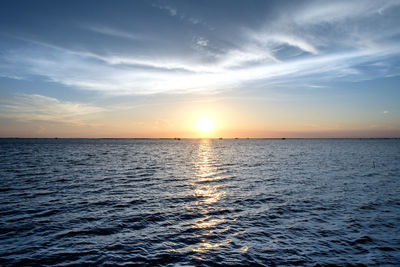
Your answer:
[248,0,400,55]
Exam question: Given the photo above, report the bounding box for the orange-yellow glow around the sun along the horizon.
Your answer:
[0,98,398,139]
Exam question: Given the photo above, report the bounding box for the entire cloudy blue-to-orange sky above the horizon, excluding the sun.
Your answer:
[0,0,400,138]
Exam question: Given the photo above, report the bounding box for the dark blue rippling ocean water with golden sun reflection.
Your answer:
[0,139,400,266]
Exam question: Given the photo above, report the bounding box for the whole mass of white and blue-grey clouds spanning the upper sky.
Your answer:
[0,0,400,95]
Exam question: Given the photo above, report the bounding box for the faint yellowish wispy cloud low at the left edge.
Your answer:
[0,94,105,125]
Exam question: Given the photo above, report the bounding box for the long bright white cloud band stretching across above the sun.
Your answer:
[0,37,399,95]
